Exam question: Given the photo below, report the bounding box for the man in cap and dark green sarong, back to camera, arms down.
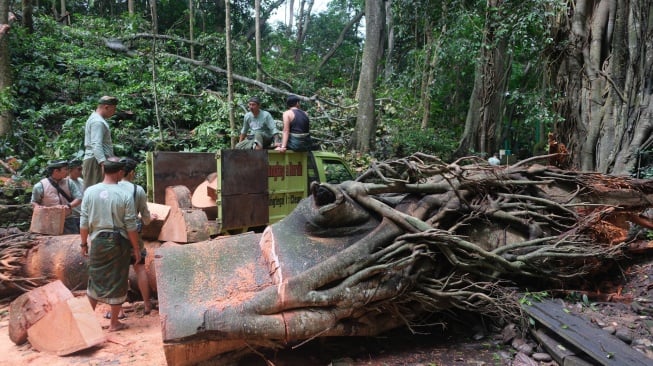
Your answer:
[80,157,141,332]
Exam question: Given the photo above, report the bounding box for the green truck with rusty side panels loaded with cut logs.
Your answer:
[147,150,354,234]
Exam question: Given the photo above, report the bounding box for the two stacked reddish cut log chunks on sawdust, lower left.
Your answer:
[9,281,106,356]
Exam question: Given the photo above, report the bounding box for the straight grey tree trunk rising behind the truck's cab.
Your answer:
[352,0,385,153]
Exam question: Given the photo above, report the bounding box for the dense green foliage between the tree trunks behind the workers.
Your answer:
[0,0,576,189]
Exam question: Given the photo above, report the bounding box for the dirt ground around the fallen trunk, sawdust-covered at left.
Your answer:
[0,256,653,366]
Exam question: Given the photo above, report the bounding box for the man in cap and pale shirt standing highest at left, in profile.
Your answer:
[82,95,118,190]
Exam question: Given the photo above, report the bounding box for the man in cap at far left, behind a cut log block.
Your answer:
[31,160,82,234]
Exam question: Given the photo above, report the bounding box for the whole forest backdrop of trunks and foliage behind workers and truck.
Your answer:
[0,0,653,180]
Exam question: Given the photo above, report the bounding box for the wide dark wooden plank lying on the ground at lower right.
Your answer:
[523,300,651,366]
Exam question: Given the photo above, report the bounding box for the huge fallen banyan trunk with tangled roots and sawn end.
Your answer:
[2,154,653,365]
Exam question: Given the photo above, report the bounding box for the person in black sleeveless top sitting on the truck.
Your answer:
[276,95,313,151]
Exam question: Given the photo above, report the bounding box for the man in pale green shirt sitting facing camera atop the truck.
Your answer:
[236,97,279,150]
